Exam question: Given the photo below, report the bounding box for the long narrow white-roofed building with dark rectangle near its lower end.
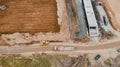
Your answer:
[82,0,99,36]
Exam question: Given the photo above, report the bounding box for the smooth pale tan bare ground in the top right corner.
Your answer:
[103,0,120,31]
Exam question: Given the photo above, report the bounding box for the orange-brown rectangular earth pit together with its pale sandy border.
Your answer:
[0,0,70,45]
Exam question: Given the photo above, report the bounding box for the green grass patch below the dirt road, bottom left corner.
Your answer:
[0,55,51,67]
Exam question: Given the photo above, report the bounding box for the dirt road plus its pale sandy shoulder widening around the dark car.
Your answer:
[0,41,120,67]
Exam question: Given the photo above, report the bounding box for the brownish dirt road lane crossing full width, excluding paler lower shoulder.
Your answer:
[0,41,120,54]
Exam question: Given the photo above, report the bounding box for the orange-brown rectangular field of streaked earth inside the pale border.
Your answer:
[0,0,60,33]
